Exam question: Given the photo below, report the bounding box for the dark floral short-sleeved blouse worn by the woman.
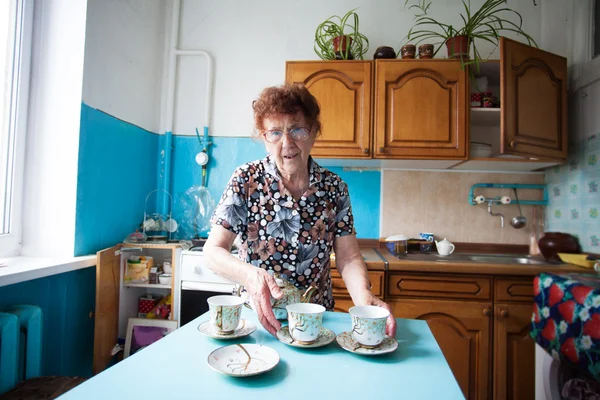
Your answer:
[212,156,355,310]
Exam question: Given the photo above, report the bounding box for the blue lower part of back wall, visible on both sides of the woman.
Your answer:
[171,136,381,239]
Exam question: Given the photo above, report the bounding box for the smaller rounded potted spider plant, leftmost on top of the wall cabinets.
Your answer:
[315,9,369,60]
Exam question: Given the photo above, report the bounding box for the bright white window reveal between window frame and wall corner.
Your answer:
[22,0,86,257]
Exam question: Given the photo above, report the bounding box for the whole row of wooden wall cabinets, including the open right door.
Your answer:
[286,38,567,171]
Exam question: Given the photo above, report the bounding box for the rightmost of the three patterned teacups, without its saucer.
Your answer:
[348,306,390,348]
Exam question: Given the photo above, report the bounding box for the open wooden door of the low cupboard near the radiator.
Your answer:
[93,246,121,374]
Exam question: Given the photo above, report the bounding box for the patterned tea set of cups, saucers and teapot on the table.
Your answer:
[198,281,398,377]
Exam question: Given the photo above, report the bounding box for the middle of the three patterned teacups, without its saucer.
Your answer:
[285,303,325,344]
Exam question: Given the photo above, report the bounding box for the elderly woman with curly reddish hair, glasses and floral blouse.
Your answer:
[204,85,396,337]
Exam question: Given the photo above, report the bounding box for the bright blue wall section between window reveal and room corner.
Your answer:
[75,104,159,255]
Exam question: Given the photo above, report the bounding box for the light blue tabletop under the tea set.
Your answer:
[60,309,464,400]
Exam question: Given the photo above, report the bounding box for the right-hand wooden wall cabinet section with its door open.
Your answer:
[452,38,568,170]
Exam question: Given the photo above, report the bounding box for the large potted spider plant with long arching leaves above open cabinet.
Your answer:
[405,0,537,66]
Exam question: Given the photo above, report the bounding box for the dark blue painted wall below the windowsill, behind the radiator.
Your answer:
[0,267,96,376]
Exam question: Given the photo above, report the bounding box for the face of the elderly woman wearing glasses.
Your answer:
[262,111,315,174]
